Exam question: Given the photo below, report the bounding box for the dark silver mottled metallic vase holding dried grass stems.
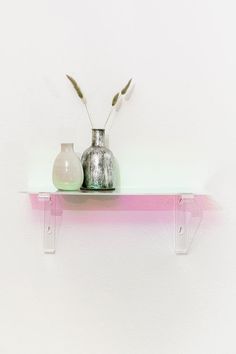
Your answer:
[81,129,115,191]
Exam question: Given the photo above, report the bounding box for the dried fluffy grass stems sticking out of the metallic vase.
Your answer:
[66,75,132,129]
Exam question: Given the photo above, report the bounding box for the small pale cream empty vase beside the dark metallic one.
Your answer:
[52,144,84,191]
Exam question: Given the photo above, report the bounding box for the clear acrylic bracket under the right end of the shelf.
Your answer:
[175,194,203,254]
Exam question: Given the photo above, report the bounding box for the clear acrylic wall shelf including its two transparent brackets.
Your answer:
[22,189,207,254]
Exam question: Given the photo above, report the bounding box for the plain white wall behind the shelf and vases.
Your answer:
[0,0,236,354]
